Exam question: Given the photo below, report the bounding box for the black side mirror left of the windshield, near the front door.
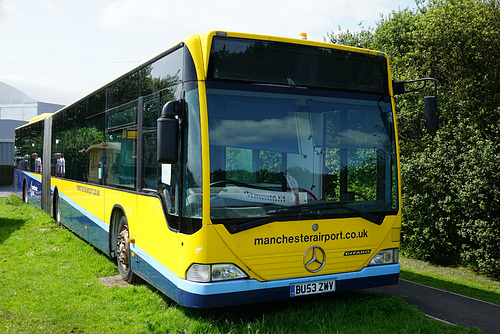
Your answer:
[156,101,182,164]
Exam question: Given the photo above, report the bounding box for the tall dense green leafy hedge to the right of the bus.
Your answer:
[329,0,500,277]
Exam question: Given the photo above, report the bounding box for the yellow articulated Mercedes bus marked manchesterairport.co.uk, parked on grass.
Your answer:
[14,31,437,308]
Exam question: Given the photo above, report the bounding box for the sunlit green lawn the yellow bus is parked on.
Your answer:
[0,196,480,334]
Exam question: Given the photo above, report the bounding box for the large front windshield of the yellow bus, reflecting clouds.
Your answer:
[207,82,398,230]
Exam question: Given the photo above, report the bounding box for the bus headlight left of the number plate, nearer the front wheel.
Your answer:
[186,263,248,283]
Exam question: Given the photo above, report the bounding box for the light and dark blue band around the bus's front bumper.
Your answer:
[130,240,400,307]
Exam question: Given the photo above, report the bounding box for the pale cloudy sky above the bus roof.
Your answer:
[0,0,415,105]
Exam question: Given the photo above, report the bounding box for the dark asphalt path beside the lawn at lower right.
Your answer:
[366,279,500,334]
